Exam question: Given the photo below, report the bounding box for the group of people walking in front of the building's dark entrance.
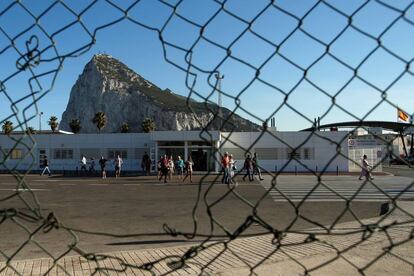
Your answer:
[157,155,194,183]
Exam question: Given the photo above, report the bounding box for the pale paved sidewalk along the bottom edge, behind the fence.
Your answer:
[0,201,414,275]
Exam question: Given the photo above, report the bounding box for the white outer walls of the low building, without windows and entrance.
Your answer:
[0,131,348,171]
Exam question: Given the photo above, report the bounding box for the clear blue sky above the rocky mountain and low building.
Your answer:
[0,0,414,130]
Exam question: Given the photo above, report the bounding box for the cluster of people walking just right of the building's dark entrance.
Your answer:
[221,152,263,184]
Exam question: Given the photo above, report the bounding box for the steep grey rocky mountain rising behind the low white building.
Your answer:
[60,54,259,133]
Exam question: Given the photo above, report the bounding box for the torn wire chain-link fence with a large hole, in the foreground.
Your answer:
[0,0,414,275]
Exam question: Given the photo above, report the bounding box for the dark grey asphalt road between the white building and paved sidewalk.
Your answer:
[0,175,396,261]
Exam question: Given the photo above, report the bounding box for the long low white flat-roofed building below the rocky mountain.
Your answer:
[0,131,349,172]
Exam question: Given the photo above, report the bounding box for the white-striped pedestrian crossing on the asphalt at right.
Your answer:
[262,183,414,202]
